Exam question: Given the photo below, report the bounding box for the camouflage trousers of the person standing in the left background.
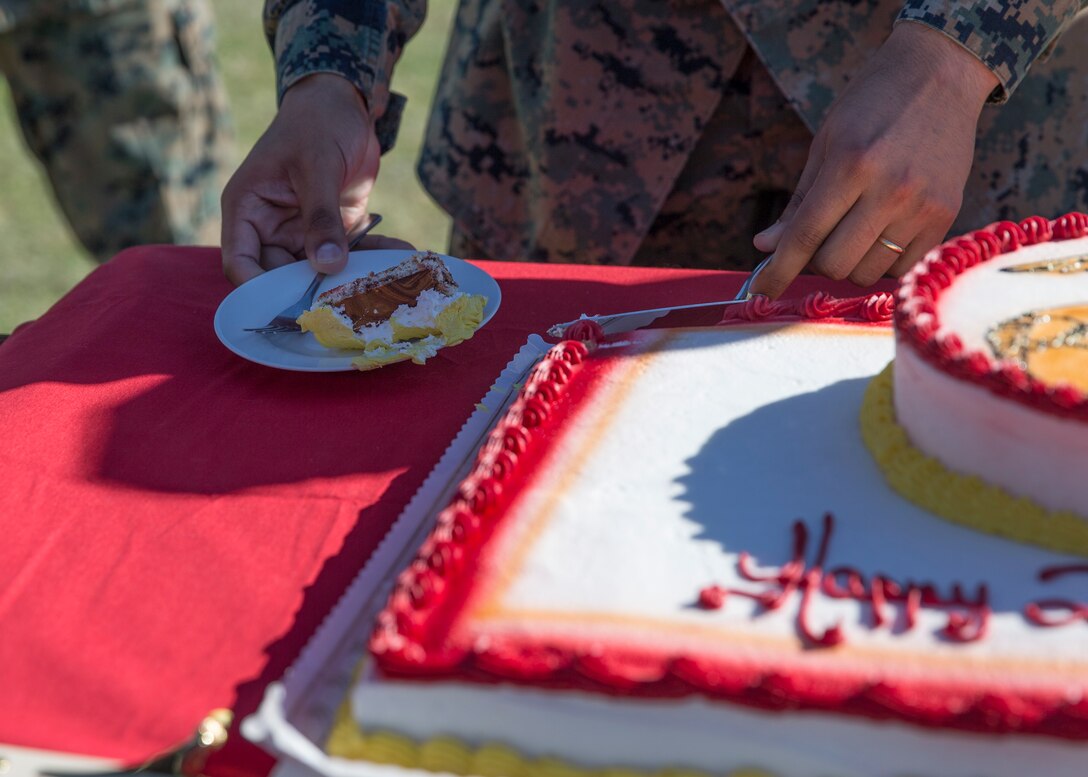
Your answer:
[0,0,233,261]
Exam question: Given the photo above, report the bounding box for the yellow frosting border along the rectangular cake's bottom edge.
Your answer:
[325,700,776,777]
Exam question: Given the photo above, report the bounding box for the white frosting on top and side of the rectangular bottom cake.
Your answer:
[353,324,1088,777]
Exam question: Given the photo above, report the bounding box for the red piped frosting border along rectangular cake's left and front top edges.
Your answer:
[369,303,1088,740]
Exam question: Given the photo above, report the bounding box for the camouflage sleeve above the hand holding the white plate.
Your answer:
[264,0,426,151]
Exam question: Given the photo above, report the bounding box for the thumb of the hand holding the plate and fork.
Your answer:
[298,153,347,275]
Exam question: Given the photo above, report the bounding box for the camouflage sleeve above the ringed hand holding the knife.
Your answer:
[895,0,1088,102]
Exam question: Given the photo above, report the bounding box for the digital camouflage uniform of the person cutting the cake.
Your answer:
[268,0,1088,268]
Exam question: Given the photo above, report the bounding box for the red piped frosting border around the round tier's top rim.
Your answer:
[894,213,1088,421]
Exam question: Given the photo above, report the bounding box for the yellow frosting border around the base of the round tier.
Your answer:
[860,362,1088,556]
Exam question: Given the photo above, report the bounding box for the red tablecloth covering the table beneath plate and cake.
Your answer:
[0,247,892,774]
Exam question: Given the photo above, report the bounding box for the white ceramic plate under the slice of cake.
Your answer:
[215,250,502,372]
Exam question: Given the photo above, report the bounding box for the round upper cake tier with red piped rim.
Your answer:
[886,213,1088,544]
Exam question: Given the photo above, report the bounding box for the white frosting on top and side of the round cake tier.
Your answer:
[895,238,1088,519]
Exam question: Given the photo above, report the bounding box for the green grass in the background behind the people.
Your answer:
[0,0,456,333]
